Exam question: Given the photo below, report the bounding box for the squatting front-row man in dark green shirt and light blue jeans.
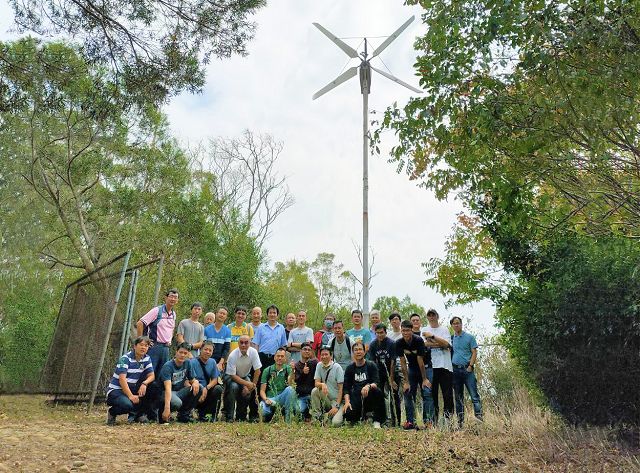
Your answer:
[260,342,295,422]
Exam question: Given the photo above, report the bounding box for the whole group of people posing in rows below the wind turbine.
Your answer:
[106,289,482,430]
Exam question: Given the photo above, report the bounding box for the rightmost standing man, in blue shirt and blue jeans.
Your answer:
[451,317,482,426]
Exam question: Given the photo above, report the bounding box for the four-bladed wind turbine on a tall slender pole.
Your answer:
[312,16,422,326]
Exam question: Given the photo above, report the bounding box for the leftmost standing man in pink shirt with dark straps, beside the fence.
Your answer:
[136,289,178,380]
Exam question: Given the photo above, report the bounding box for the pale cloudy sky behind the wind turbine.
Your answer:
[0,0,495,333]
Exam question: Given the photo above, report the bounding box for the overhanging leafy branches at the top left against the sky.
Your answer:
[0,0,266,104]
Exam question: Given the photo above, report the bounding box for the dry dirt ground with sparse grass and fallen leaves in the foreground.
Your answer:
[0,396,640,473]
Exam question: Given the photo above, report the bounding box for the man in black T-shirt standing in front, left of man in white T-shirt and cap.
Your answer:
[395,320,433,430]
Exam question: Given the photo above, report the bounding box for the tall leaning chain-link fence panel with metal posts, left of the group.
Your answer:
[40,252,162,408]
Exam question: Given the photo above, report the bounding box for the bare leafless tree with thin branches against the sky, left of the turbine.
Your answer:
[195,130,293,248]
